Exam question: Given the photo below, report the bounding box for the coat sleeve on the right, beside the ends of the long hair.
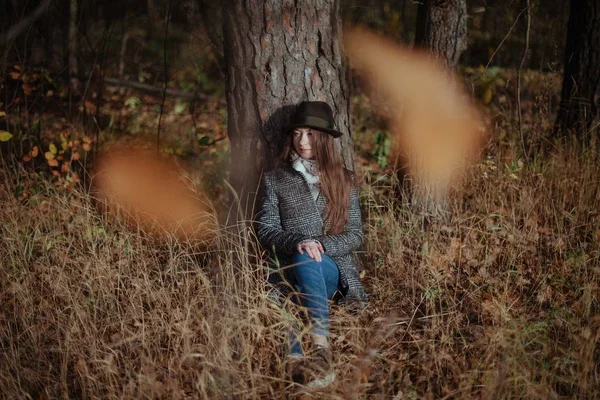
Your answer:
[315,187,363,257]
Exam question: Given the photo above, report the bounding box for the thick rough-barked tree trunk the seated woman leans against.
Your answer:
[223,0,353,214]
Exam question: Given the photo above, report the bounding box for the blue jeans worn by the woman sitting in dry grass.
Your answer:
[290,252,340,355]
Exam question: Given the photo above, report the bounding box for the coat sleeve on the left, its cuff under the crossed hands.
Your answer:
[254,173,310,255]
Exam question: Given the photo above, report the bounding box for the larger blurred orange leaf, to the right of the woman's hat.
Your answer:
[344,29,483,196]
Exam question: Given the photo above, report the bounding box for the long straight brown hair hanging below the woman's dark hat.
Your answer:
[279,129,353,235]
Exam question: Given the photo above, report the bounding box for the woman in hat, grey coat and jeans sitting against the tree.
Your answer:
[255,101,366,387]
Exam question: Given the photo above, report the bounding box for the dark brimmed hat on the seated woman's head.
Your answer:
[284,101,342,137]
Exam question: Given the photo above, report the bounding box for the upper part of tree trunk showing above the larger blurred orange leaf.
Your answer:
[415,0,467,69]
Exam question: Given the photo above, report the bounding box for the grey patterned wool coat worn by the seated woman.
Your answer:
[255,165,366,300]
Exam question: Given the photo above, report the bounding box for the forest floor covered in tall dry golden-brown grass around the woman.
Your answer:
[0,70,600,399]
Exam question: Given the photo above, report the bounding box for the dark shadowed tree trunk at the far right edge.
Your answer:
[555,0,600,140]
